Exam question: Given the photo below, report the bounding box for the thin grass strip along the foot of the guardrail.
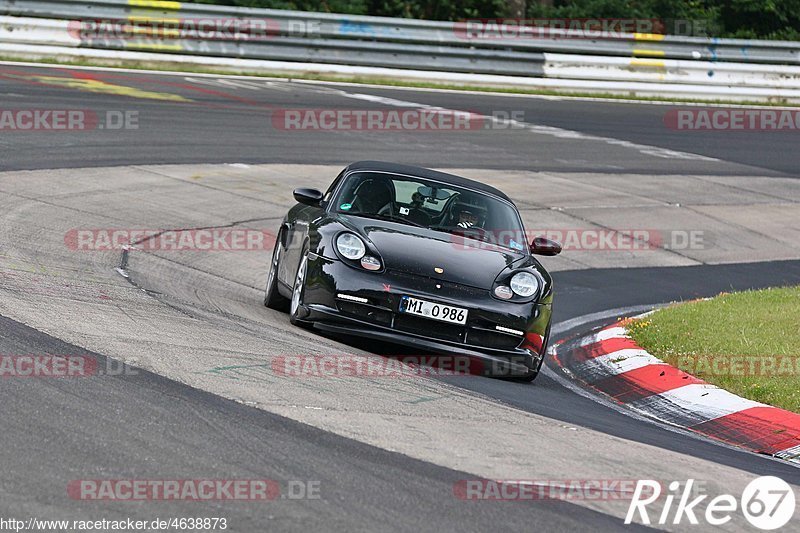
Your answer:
[0,56,800,107]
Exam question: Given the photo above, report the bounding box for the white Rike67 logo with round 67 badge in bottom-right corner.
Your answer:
[625,476,795,531]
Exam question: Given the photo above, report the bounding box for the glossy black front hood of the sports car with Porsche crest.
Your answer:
[342,217,526,290]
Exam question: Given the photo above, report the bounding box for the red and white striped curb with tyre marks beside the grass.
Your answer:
[554,322,800,463]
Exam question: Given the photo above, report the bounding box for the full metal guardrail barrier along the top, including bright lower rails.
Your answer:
[0,0,800,101]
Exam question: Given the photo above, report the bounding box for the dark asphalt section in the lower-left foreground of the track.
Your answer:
[0,317,645,532]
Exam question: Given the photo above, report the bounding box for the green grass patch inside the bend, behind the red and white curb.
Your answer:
[629,287,800,413]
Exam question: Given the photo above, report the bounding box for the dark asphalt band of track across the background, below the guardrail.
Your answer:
[0,64,797,177]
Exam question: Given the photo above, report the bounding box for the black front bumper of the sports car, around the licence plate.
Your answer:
[296,254,551,375]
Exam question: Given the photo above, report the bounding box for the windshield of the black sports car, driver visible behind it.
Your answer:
[333,172,525,251]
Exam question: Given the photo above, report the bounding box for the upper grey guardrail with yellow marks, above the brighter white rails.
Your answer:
[0,0,800,65]
